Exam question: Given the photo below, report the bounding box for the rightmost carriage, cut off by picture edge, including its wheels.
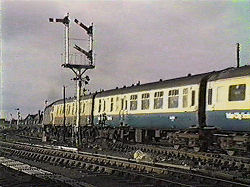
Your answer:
[206,66,250,154]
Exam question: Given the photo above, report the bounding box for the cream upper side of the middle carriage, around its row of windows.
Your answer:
[94,84,199,115]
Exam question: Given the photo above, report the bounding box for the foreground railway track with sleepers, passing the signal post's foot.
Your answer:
[0,141,249,186]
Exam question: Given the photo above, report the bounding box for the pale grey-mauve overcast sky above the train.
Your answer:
[0,0,250,117]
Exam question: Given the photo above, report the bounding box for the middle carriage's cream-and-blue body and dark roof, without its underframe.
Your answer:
[94,73,213,130]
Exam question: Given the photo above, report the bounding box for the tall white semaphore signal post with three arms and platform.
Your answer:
[49,13,95,146]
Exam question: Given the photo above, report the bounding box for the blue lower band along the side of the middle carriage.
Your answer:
[94,112,198,129]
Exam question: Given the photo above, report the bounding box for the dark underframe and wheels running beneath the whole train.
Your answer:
[39,125,250,155]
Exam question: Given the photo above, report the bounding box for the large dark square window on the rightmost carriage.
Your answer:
[228,84,246,101]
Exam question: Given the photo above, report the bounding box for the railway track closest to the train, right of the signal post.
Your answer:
[108,143,250,172]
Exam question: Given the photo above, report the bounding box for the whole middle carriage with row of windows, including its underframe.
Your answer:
[94,72,215,147]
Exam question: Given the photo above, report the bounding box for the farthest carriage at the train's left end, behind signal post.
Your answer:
[43,94,94,139]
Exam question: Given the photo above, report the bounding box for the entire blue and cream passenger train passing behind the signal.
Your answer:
[43,65,250,155]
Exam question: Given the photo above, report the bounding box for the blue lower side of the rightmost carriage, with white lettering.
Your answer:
[206,110,250,132]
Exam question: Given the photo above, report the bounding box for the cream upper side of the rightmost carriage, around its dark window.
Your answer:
[206,76,250,111]
